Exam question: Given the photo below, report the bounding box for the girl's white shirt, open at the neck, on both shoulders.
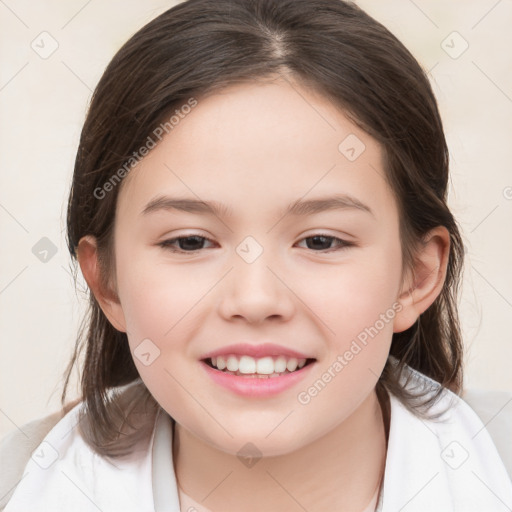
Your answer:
[4,362,512,512]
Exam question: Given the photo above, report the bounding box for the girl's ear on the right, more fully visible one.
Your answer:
[393,226,450,332]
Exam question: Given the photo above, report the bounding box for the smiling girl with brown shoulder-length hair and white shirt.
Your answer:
[3,0,512,512]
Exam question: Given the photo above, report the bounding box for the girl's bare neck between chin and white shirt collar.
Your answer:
[173,391,389,512]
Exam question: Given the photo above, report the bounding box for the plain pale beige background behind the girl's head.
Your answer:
[0,0,512,435]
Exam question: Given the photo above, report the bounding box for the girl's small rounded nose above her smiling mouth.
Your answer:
[218,251,295,324]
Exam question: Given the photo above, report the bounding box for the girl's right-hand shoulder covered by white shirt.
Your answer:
[381,367,512,512]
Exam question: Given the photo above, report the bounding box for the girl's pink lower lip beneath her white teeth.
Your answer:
[200,361,315,397]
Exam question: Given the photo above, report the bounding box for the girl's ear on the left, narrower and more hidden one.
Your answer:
[77,235,126,332]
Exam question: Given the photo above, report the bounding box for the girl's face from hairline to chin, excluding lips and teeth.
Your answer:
[109,81,408,455]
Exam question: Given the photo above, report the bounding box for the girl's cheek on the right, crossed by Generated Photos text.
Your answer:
[297,247,401,430]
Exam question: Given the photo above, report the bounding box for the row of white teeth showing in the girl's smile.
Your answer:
[211,355,306,375]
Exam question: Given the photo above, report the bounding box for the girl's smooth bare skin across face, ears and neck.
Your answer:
[79,77,449,512]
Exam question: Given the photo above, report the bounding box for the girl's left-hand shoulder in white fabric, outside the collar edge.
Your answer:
[0,382,158,512]
